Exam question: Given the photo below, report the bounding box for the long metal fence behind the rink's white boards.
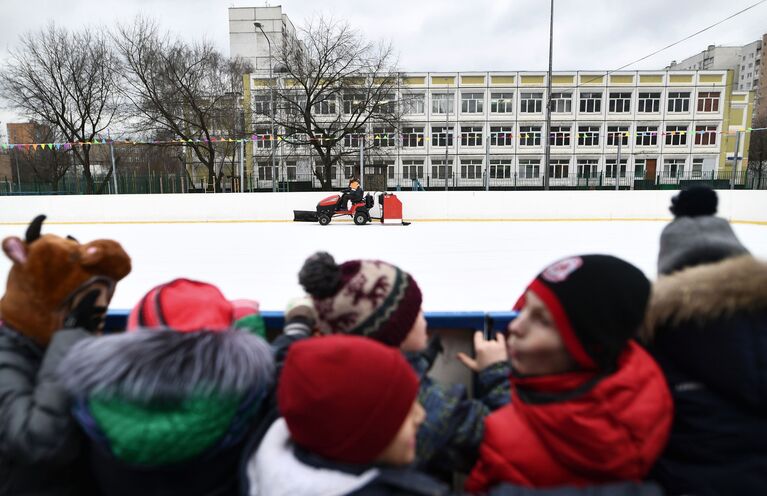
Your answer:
[0,171,767,195]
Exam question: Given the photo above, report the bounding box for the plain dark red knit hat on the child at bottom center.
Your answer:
[277,335,418,464]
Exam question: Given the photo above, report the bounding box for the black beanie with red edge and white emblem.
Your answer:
[515,255,650,371]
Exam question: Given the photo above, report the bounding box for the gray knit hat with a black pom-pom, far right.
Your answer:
[658,187,748,274]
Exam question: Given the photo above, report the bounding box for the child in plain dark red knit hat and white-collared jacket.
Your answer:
[247,335,447,496]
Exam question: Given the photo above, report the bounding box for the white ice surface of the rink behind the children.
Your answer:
[0,221,767,311]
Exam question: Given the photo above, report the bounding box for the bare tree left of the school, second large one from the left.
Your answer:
[114,18,251,191]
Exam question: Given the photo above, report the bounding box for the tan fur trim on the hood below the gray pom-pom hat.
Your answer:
[641,255,767,341]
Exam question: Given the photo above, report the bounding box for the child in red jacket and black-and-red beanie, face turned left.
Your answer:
[466,255,672,492]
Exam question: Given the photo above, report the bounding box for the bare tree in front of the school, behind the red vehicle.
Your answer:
[266,18,399,190]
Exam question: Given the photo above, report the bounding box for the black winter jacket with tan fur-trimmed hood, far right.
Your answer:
[644,256,767,495]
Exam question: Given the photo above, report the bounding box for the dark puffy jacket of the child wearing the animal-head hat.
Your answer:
[0,325,90,496]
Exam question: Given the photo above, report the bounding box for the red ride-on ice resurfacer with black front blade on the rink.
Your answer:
[293,193,410,226]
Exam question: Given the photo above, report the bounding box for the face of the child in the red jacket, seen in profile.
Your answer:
[506,291,575,375]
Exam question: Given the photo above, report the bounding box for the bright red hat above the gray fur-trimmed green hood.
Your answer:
[127,279,235,332]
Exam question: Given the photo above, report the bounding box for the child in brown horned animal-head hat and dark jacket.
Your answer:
[0,215,131,495]
